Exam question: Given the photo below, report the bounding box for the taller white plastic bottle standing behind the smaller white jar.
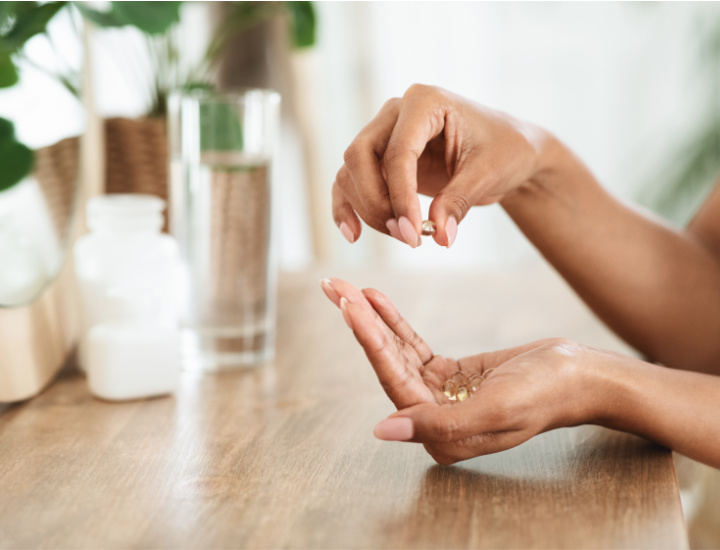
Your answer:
[75,194,178,370]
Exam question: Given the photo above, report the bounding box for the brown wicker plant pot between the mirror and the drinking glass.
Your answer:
[105,117,168,231]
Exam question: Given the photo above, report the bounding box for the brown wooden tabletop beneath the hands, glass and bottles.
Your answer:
[0,268,687,548]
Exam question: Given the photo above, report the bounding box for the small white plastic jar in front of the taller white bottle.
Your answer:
[87,287,180,401]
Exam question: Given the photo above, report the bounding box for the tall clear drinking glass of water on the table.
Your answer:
[168,90,280,371]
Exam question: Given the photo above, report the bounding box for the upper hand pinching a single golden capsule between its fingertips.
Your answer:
[332,84,548,248]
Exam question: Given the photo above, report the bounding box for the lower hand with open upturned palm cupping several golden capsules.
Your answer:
[322,279,600,464]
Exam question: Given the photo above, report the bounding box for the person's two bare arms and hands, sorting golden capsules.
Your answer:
[330,85,720,468]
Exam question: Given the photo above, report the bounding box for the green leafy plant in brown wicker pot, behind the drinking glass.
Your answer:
[78,2,315,222]
